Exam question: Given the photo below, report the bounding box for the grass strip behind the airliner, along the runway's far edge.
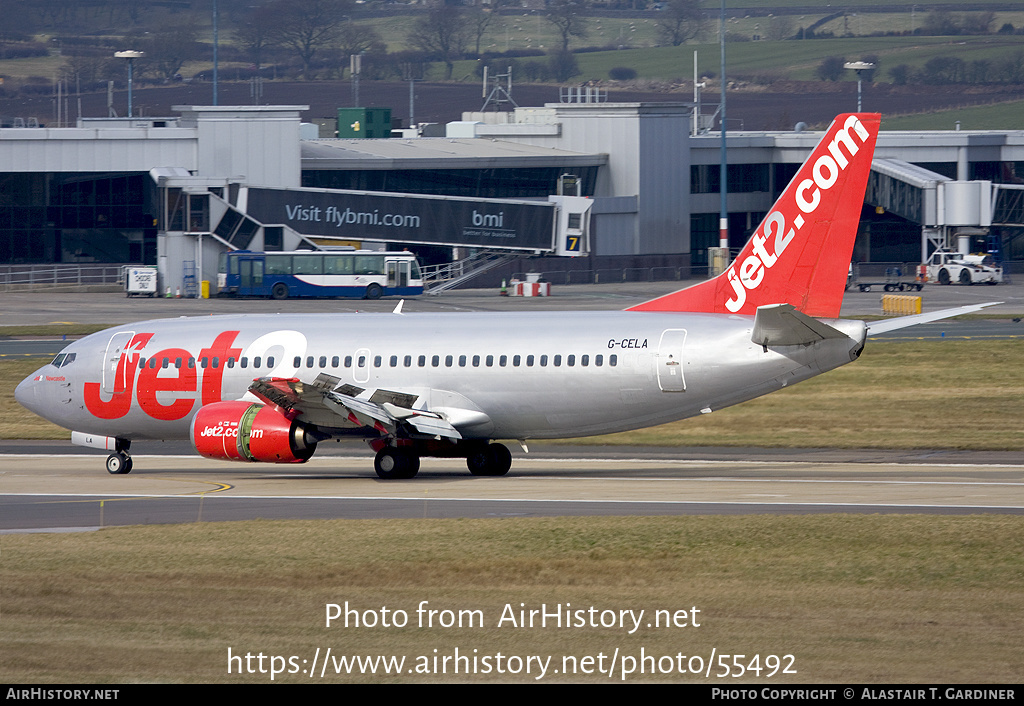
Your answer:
[0,339,1024,451]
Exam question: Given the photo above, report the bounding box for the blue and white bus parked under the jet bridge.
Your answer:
[217,250,423,299]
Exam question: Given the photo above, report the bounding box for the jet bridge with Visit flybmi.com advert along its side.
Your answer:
[151,174,593,295]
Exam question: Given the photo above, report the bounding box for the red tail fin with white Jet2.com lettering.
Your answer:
[629,113,882,318]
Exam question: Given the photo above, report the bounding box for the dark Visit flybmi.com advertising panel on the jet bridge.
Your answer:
[248,189,555,250]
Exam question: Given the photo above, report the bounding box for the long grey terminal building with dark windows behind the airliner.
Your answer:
[0,102,1024,288]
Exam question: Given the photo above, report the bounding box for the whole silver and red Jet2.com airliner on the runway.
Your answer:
[16,114,984,479]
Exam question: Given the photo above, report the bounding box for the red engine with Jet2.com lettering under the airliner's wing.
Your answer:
[189,402,317,463]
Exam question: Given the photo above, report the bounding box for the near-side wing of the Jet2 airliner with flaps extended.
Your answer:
[249,373,462,440]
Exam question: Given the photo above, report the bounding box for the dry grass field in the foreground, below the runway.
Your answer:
[0,512,1024,683]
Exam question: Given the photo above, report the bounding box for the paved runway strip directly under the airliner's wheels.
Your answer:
[0,454,1024,532]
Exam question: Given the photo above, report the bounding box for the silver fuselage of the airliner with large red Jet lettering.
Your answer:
[16,312,864,439]
